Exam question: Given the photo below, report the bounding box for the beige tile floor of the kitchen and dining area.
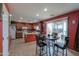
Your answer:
[10,39,79,56]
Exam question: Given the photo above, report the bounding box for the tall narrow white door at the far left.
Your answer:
[2,5,9,56]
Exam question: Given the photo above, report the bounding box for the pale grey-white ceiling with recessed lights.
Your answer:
[9,3,79,23]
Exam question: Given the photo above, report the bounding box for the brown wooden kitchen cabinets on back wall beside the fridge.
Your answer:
[14,22,35,39]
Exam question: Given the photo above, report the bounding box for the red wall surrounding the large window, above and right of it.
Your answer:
[41,10,79,50]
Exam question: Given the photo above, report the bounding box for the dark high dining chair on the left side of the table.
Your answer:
[36,35,47,56]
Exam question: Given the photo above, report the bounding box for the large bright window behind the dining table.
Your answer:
[46,20,68,36]
